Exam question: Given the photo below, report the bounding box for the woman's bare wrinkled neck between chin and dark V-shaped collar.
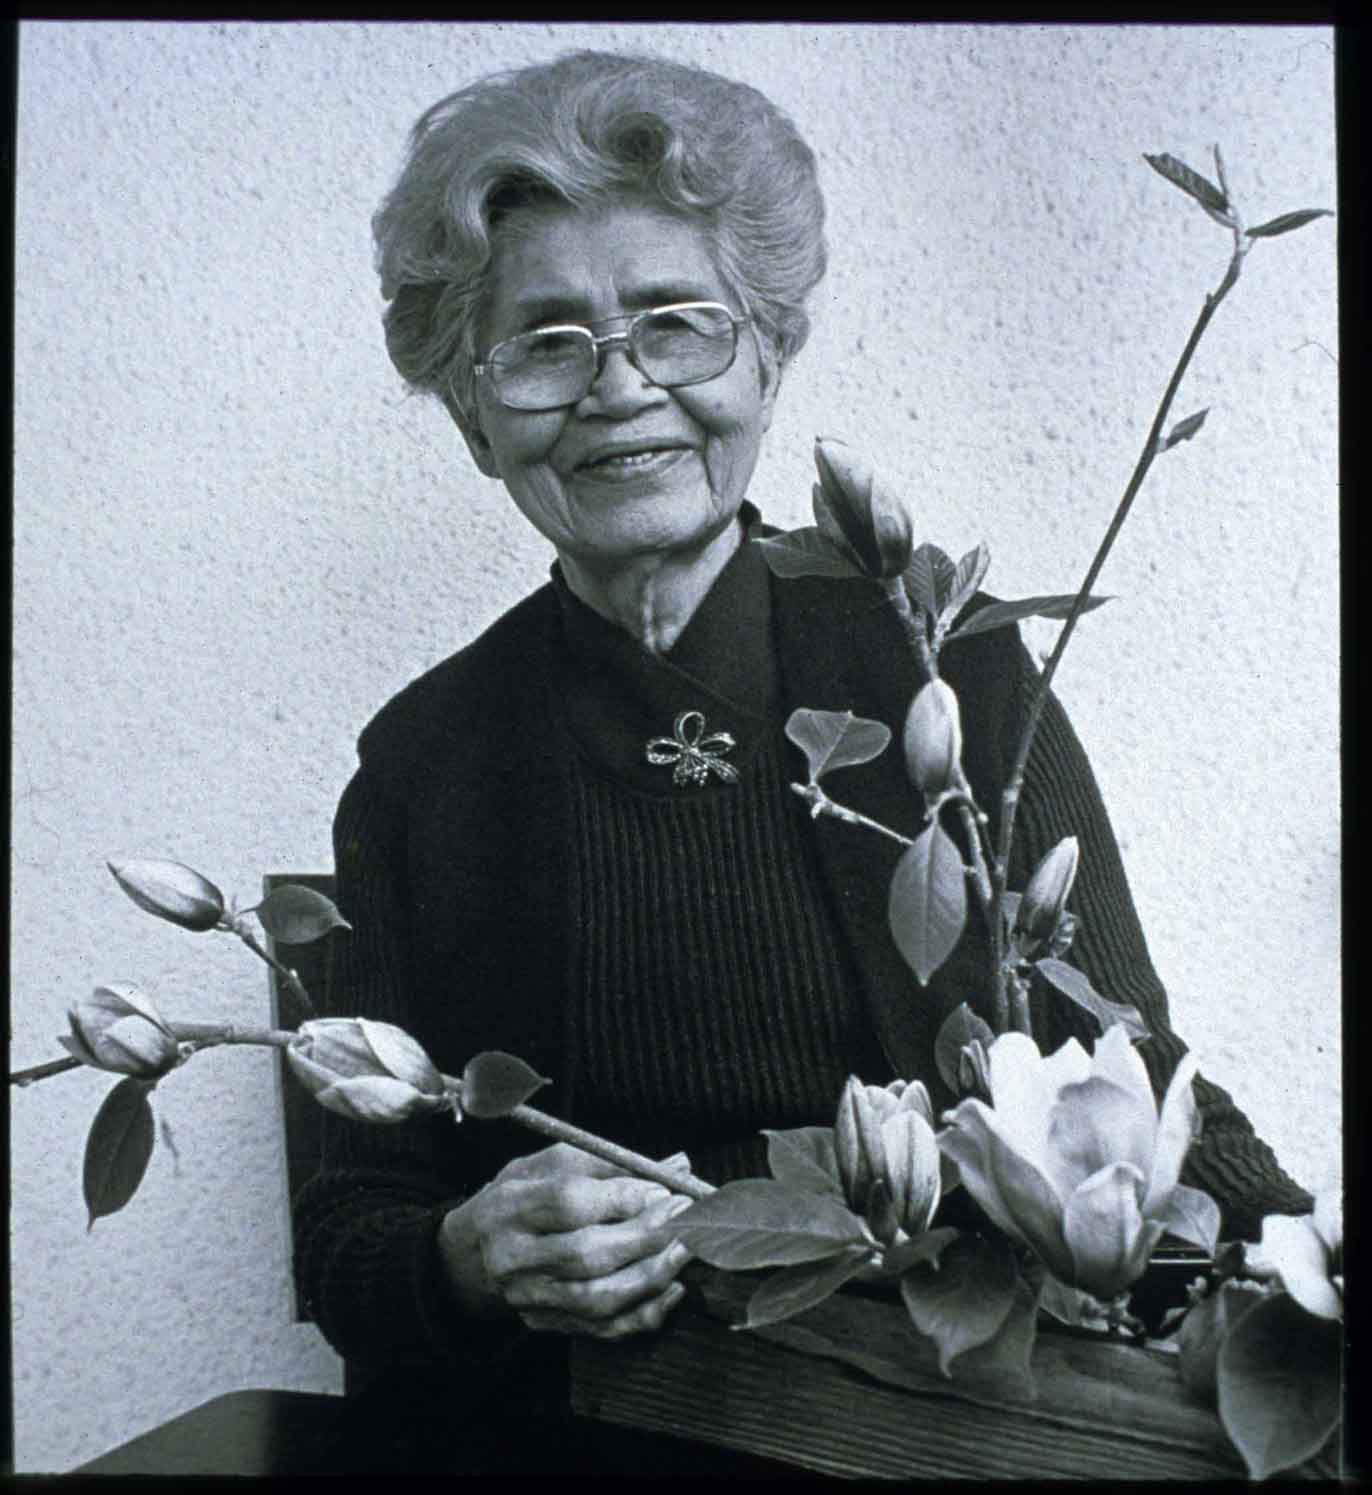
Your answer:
[559,519,743,653]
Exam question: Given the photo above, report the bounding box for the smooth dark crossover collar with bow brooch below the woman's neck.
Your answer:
[553,504,780,797]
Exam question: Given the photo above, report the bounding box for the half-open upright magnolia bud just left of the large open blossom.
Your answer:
[834,1076,942,1244]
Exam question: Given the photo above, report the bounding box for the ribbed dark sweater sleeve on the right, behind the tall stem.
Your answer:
[1006,646,1312,1239]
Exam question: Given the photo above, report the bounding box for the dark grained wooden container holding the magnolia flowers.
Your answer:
[572,1272,1333,1483]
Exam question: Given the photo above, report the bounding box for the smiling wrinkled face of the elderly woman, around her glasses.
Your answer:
[463,203,777,573]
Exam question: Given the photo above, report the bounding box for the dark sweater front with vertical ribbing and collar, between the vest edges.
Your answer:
[557,538,894,1181]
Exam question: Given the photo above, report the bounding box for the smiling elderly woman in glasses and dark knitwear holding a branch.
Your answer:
[296,52,1309,1471]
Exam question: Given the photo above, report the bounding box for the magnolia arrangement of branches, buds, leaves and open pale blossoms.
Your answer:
[10,150,1342,1477]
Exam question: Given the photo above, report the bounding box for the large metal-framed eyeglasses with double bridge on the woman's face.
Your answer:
[475,300,752,410]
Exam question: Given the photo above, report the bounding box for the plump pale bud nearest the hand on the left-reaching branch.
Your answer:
[285,1018,451,1123]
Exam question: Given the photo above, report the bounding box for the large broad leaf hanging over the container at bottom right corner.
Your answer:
[1217,1293,1344,1480]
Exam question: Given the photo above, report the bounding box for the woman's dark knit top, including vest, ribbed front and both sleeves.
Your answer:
[294,520,1311,1380]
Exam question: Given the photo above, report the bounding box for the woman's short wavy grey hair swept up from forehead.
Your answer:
[372,51,825,419]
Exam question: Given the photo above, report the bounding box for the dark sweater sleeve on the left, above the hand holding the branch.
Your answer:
[294,767,523,1366]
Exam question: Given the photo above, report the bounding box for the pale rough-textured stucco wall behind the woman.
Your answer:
[12,24,1339,1471]
